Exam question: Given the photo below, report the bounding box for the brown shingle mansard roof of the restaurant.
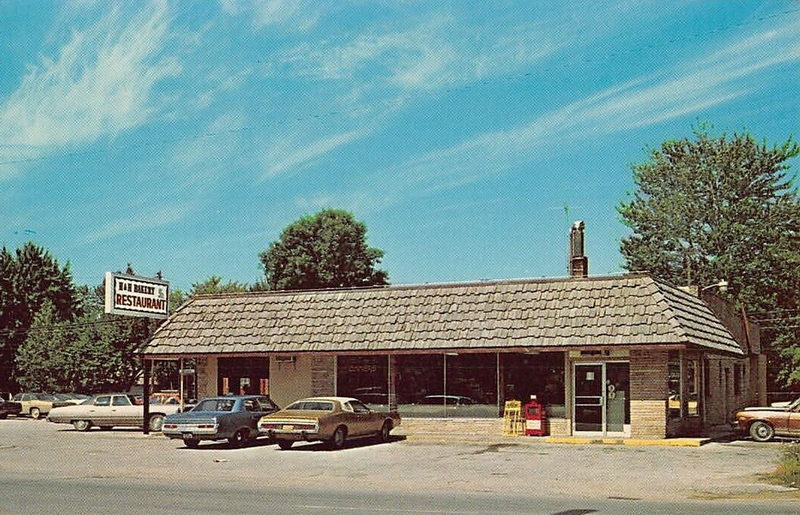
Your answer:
[142,275,742,355]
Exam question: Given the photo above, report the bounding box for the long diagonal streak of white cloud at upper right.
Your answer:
[310,13,800,209]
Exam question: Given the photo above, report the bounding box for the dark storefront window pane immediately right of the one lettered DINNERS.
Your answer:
[395,354,446,417]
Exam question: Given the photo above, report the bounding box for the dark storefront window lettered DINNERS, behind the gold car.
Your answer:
[336,356,389,411]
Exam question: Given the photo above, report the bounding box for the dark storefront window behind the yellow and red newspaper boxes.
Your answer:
[500,352,566,417]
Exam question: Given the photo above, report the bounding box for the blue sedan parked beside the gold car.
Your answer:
[161,395,280,448]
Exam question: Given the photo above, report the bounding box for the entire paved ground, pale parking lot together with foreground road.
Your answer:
[0,419,800,514]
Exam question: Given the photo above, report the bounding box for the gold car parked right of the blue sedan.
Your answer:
[258,397,400,450]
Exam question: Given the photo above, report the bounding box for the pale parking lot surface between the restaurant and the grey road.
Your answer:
[0,417,798,512]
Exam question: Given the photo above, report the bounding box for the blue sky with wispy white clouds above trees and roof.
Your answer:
[0,0,800,290]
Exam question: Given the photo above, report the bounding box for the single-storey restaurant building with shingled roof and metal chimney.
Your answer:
[143,225,766,438]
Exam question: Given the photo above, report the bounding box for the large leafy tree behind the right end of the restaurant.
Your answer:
[618,126,800,385]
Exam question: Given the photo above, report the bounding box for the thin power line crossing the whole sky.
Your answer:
[0,8,800,166]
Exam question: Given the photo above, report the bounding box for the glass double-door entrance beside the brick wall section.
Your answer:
[572,361,630,436]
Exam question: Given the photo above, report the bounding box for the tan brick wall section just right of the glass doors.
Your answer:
[630,350,668,438]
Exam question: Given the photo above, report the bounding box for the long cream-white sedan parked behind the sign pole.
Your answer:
[47,393,180,431]
